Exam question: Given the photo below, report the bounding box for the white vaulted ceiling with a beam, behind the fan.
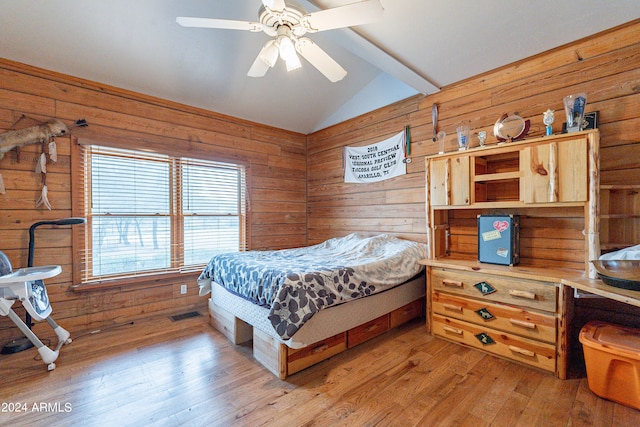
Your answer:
[0,0,640,133]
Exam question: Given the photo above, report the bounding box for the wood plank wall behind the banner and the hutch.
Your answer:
[307,21,640,258]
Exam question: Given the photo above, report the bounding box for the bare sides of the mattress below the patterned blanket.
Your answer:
[209,273,425,348]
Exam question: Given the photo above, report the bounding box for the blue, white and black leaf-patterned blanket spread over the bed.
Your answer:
[198,234,426,340]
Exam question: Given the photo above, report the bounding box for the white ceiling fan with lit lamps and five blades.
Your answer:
[176,0,384,82]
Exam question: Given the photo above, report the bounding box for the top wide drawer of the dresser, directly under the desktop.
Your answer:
[431,268,558,313]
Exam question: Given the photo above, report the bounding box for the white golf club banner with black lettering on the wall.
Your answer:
[344,131,407,183]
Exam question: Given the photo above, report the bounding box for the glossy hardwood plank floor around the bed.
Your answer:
[0,315,640,427]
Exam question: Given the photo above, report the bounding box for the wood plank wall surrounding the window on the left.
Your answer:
[0,59,307,345]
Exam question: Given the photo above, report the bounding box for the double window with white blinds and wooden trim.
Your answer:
[75,145,246,282]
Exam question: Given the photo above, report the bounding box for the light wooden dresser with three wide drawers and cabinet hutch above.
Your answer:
[421,130,600,378]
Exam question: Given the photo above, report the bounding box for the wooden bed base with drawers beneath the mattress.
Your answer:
[209,298,425,379]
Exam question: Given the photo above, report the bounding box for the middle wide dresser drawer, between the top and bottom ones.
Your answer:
[432,292,556,344]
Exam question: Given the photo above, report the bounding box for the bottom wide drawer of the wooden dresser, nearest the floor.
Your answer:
[433,314,556,372]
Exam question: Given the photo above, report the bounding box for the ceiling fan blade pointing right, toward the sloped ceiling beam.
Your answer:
[304,0,384,33]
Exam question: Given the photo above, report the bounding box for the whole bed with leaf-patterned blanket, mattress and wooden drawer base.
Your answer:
[198,233,426,379]
